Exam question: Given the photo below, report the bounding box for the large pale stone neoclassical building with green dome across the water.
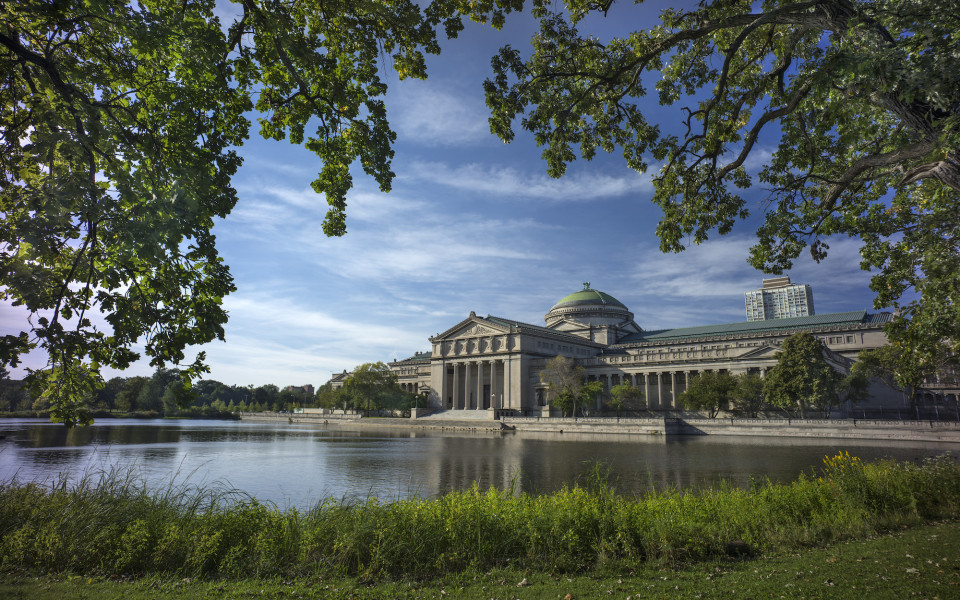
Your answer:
[374,283,908,416]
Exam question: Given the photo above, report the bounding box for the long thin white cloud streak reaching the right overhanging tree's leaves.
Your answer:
[403,162,653,202]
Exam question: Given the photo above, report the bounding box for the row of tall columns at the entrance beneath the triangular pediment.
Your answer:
[441,359,512,410]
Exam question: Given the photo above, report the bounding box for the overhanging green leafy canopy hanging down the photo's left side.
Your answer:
[0,0,522,424]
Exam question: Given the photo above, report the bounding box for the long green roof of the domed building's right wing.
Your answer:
[618,310,892,344]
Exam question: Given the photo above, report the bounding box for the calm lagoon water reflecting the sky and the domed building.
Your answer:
[0,419,960,508]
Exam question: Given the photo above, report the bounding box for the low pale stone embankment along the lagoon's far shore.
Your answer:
[240,413,960,444]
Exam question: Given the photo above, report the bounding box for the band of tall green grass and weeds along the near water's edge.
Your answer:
[0,454,960,578]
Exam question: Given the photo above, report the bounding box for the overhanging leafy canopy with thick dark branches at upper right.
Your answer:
[485,0,960,376]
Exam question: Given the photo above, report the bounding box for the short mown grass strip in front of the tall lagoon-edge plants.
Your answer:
[0,521,960,600]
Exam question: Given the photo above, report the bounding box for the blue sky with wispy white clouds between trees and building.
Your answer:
[0,5,873,386]
